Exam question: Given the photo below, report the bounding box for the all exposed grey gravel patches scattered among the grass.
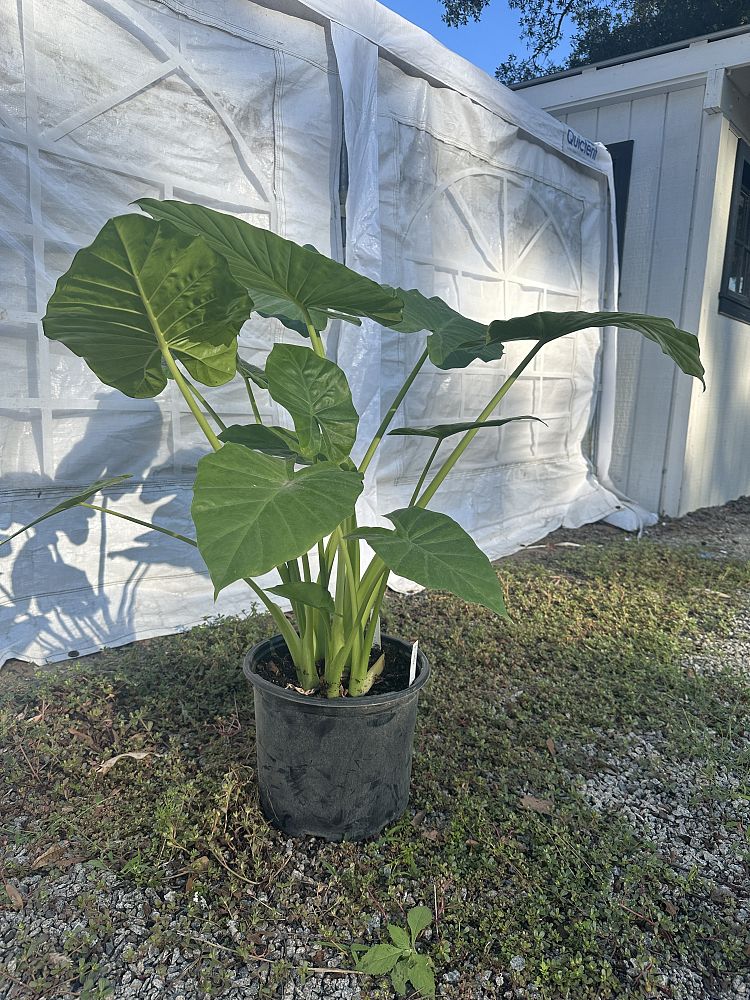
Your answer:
[0,500,750,1000]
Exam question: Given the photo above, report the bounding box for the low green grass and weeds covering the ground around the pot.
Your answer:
[0,541,750,1000]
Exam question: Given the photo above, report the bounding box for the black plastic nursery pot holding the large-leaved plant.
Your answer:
[243,635,430,841]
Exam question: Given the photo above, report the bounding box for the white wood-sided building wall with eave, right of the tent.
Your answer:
[523,29,750,516]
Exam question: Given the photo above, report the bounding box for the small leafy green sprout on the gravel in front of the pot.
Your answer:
[352,906,435,997]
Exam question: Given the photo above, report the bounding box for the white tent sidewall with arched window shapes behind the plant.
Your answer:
[0,0,617,663]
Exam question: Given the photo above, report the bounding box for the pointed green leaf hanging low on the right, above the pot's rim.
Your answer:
[350,508,507,616]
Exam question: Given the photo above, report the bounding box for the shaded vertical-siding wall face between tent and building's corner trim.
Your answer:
[566,85,704,513]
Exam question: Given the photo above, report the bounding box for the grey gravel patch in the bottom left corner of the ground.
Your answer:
[0,841,362,1000]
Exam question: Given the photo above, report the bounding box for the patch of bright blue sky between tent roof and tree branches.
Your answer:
[380,0,576,76]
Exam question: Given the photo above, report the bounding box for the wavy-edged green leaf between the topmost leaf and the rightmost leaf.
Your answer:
[387,288,503,369]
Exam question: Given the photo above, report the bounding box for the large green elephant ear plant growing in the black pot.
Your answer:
[1,199,703,836]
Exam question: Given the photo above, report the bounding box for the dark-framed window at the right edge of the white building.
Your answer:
[719,142,750,323]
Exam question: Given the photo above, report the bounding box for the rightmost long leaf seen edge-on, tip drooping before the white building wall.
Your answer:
[487,312,705,386]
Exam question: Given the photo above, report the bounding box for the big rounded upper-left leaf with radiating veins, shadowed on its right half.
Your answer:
[43,215,252,398]
